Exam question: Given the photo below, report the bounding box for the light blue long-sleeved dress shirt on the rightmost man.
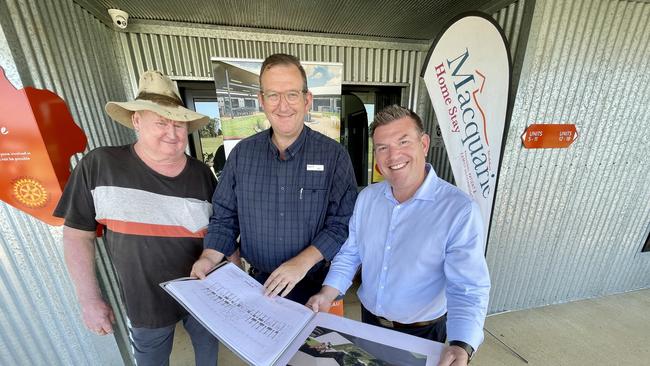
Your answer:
[324,164,490,350]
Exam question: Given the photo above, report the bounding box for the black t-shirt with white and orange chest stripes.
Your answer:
[54,145,216,328]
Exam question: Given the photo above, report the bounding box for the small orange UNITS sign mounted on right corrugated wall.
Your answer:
[521,124,578,149]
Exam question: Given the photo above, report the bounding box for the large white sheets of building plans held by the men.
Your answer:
[161,263,443,366]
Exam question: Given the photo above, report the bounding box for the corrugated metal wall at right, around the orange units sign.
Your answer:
[487,0,650,312]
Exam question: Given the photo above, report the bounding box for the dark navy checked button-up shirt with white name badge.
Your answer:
[204,126,357,272]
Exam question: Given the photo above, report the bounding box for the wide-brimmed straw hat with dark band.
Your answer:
[105,71,210,133]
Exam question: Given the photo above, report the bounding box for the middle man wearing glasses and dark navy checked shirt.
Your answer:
[192,54,357,304]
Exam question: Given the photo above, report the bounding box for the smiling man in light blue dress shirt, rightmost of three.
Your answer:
[307,105,490,365]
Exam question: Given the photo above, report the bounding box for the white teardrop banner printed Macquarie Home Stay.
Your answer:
[422,12,511,238]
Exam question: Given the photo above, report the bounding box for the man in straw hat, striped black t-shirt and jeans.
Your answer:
[54,71,225,365]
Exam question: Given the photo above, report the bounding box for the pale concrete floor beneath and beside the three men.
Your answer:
[170,289,650,366]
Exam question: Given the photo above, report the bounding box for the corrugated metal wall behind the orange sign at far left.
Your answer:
[0,0,133,365]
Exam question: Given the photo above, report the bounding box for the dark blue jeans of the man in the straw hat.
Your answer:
[130,315,219,366]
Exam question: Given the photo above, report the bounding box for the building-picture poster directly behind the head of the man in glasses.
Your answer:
[212,57,343,156]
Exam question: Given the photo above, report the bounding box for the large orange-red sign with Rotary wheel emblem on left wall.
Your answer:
[0,68,86,225]
